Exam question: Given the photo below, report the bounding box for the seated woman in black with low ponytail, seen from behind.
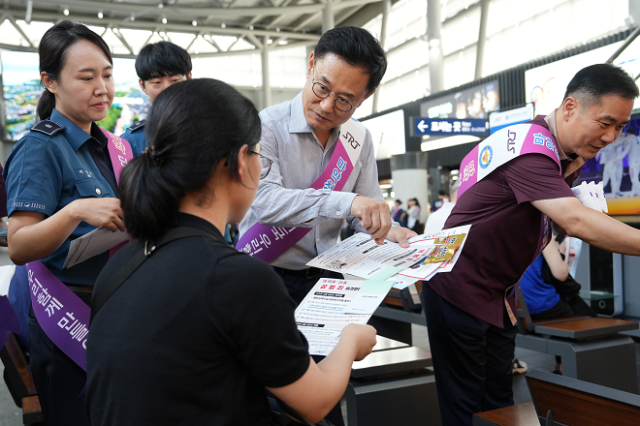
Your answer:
[86,79,375,426]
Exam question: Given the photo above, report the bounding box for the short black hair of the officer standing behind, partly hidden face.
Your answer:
[136,41,192,81]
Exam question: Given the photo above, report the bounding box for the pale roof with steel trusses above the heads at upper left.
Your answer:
[0,0,392,58]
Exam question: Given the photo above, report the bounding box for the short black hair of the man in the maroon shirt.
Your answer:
[563,64,638,103]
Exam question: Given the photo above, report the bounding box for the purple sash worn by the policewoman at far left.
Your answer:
[19,129,133,371]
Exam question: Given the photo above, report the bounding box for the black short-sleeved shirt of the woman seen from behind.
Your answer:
[86,214,309,426]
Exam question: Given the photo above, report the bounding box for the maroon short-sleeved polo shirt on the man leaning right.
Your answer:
[426,116,579,327]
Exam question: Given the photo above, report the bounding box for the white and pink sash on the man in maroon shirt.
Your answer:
[458,124,562,260]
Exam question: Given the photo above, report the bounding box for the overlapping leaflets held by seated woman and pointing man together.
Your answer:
[295,225,471,356]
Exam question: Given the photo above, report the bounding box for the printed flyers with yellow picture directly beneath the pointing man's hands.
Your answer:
[307,225,471,279]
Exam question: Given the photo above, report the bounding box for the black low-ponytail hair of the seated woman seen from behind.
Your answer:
[119,78,262,241]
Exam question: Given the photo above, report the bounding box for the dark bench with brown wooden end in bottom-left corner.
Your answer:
[0,333,44,426]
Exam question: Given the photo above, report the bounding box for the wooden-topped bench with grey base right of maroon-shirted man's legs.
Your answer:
[516,289,640,392]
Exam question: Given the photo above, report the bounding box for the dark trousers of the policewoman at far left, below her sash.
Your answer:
[29,294,91,426]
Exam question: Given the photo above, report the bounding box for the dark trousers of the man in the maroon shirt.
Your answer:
[421,285,517,426]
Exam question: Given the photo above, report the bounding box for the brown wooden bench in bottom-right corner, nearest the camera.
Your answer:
[473,370,640,426]
